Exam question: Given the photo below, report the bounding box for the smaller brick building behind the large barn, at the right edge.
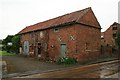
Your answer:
[101,22,120,47]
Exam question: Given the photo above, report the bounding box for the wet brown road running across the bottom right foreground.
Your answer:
[17,60,120,78]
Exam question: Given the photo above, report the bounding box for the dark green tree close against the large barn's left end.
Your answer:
[12,35,20,54]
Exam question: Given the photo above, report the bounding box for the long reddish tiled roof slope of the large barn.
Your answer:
[18,7,100,34]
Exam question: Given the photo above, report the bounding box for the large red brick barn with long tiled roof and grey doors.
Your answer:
[18,7,101,61]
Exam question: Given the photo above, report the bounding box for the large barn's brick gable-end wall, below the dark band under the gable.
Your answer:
[69,24,101,60]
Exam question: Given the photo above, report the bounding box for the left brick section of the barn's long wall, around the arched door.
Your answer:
[21,30,48,56]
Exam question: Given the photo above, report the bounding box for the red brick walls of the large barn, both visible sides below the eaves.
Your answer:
[21,24,101,60]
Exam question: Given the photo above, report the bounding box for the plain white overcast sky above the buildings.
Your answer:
[0,0,120,39]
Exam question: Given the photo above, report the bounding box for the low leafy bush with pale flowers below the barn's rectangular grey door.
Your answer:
[57,57,77,64]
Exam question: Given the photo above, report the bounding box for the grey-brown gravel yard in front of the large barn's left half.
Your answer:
[2,55,75,73]
